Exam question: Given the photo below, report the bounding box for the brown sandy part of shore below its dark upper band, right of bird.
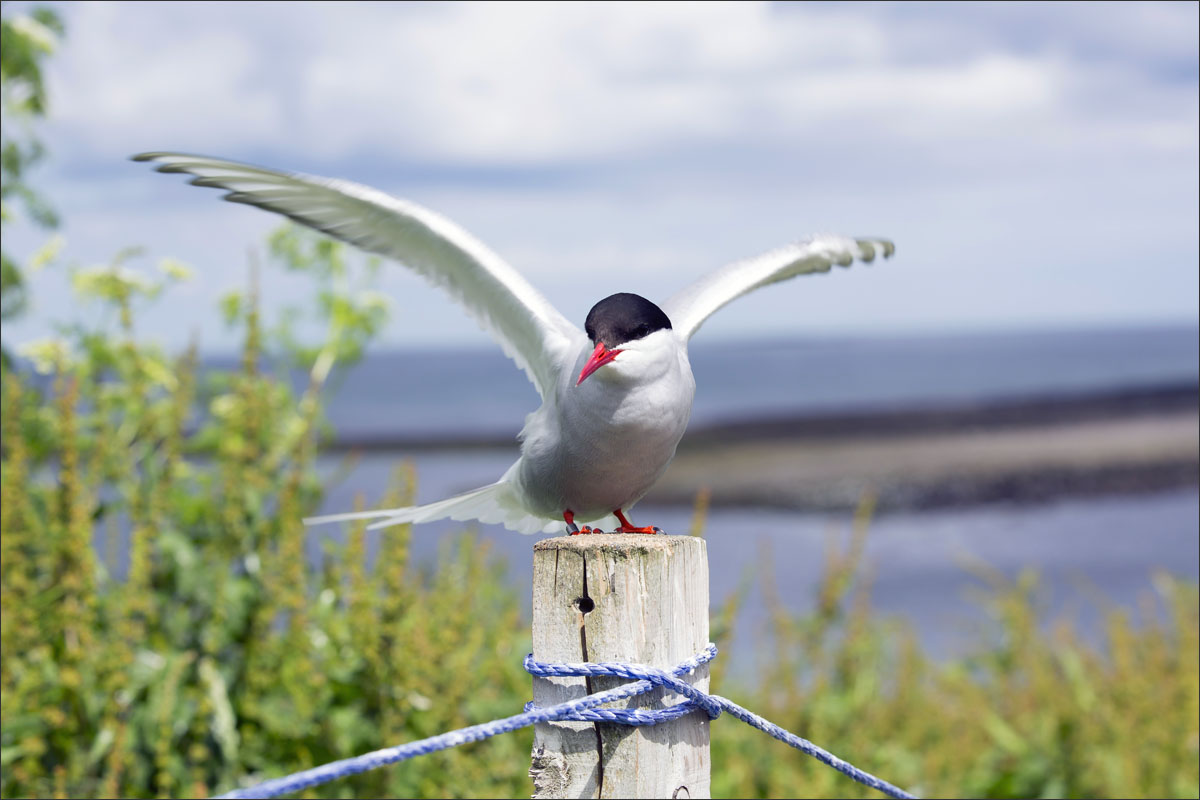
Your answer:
[647,408,1200,511]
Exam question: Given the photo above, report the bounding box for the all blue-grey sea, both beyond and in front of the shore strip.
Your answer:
[308,324,1200,673]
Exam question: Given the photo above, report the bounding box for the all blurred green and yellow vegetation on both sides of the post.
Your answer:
[0,10,1200,798]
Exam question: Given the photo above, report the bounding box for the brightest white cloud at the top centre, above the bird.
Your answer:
[283,2,1060,163]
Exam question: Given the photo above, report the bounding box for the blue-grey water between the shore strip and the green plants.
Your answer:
[310,451,1200,670]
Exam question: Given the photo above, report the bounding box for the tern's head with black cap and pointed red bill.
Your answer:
[575,291,671,386]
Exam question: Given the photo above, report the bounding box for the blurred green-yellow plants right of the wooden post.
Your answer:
[712,503,1200,798]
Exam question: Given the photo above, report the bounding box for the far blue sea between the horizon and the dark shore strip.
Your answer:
[314,326,1200,439]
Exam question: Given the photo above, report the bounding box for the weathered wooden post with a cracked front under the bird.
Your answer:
[529,534,709,798]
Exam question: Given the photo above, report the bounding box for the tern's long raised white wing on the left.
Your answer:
[133,152,583,397]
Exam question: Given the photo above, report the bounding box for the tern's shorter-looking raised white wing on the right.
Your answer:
[662,235,895,339]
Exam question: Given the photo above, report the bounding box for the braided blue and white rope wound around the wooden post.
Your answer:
[220,644,914,798]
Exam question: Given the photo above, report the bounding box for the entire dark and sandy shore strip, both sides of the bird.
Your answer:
[326,383,1200,510]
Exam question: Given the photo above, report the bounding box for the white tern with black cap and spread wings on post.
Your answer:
[132,152,895,534]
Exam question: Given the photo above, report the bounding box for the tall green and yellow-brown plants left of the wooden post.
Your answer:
[0,234,530,796]
